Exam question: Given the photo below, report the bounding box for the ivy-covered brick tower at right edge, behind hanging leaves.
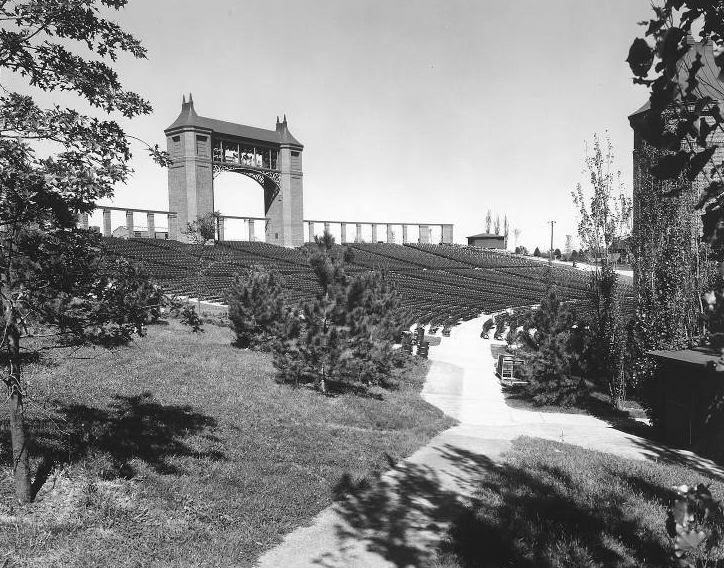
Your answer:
[629,41,724,348]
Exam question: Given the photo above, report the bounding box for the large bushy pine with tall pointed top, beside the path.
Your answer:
[274,231,404,392]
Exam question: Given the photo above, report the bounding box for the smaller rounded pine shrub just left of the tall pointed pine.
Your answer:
[227,266,285,351]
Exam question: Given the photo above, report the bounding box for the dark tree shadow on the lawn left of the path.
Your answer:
[3,392,225,495]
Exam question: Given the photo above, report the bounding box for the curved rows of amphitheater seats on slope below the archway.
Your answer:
[103,237,633,328]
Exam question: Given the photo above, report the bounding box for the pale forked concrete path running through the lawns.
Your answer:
[257,317,724,568]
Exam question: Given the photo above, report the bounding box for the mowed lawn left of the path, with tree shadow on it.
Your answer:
[0,323,452,568]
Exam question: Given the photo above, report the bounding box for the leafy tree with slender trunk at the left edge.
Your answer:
[0,0,173,502]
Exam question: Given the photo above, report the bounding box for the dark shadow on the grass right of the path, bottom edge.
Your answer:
[442,454,669,568]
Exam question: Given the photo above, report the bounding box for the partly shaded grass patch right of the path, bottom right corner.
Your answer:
[429,437,724,568]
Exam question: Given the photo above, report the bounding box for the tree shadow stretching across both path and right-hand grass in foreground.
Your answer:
[316,446,671,568]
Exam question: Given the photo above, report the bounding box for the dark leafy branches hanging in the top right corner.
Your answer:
[627,4,724,245]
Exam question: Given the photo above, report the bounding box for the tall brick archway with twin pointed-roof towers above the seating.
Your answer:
[164,95,304,247]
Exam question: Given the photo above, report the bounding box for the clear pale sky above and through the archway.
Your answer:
[72,0,651,250]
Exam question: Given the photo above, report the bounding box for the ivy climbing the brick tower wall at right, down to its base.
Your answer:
[628,141,717,424]
